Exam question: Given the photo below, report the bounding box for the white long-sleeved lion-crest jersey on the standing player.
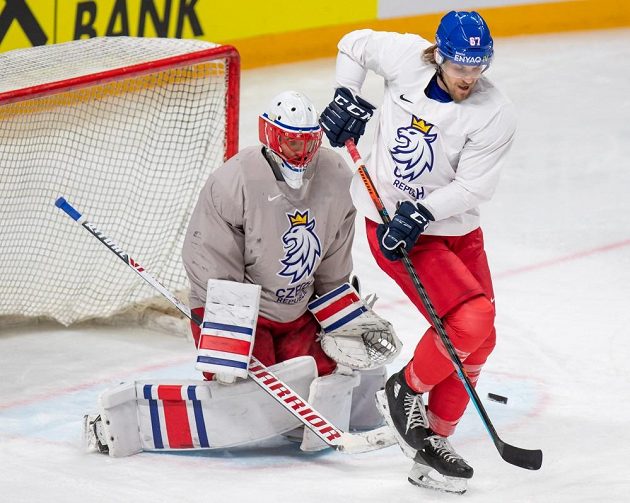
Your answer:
[336,30,516,236]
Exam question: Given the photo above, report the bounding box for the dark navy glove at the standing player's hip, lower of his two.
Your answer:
[376,201,435,261]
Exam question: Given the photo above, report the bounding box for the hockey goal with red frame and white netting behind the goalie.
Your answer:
[0,37,240,326]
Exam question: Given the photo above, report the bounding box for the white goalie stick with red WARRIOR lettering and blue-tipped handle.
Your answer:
[55,197,396,454]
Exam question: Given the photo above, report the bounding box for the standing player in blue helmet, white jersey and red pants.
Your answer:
[320,11,516,492]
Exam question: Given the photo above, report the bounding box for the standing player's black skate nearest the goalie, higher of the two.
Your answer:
[376,369,429,459]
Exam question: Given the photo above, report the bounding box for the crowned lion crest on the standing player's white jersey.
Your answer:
[390,116,437,182]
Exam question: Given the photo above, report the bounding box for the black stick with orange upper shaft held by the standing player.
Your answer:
[346,138,542,470]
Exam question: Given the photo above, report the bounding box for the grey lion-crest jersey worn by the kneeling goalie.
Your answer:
[183,146,356,322]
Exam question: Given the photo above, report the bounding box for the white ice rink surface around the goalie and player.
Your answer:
[0,30,630,503]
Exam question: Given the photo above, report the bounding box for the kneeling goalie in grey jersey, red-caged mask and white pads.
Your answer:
[85,91,401,456]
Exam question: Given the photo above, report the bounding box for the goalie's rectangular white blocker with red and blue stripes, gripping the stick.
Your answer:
[195,279,261,383]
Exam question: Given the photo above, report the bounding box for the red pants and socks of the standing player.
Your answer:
[366,220,496,436]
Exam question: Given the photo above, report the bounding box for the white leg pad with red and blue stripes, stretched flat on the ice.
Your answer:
[94,356,317,457]
